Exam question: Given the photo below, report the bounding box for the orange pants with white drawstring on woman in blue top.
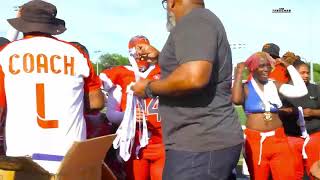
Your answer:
[244,128,295,180]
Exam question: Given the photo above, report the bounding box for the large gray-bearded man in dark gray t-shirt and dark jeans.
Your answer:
[132,0,243,180]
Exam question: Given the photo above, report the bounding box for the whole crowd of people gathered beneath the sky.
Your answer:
[0,0,320,180]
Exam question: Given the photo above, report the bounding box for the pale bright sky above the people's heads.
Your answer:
[0,0,320,62]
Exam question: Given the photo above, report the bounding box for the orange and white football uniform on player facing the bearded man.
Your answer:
[100,65,165,180]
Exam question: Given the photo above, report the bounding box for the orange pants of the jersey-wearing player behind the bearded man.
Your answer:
[126,144,165,180]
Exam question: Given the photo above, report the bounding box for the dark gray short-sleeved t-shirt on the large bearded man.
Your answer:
[159,8,243,152]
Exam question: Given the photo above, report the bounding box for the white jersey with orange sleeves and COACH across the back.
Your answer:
[0,36,101,173]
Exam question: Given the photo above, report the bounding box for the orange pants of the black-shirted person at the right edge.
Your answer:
[288,132,320,180]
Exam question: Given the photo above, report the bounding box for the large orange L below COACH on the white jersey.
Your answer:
[36,83,59,129]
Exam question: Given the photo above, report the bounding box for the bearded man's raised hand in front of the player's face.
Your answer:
[135,44,159,64]
